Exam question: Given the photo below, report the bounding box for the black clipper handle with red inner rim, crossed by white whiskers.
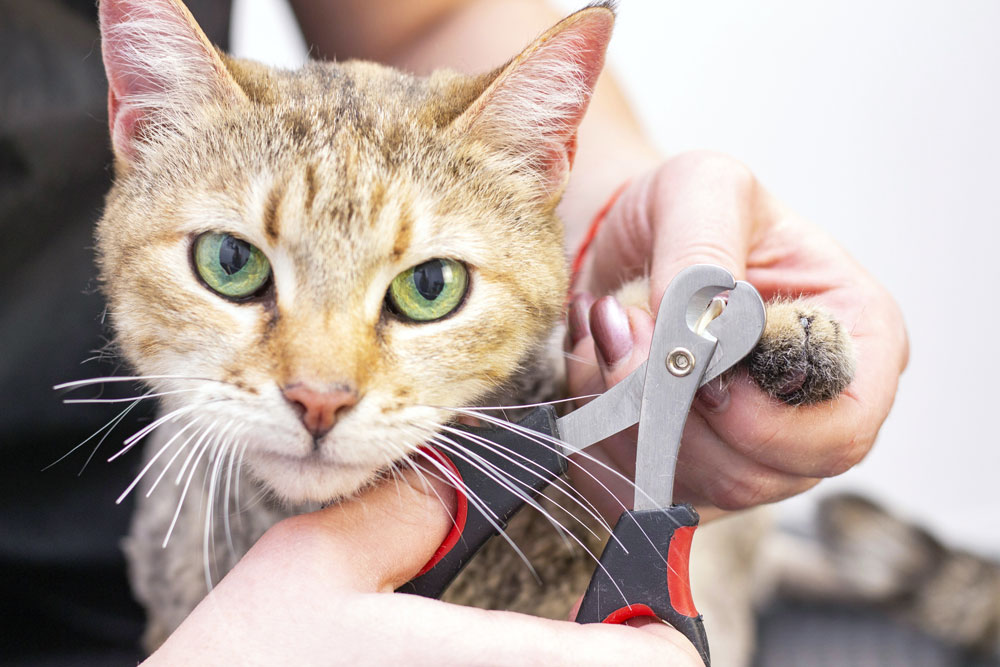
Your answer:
[397,405,568,598]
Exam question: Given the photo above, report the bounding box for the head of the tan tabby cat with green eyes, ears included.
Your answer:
[97,0,613,502]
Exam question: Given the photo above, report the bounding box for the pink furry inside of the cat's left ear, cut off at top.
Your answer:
[100,0,245,162]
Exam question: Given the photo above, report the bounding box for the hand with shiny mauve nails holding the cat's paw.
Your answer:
[568,152,908,518]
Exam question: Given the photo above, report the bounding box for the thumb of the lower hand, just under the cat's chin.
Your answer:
[248,464,455,592]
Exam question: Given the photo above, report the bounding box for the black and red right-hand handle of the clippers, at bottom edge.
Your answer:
[576,505,711,665]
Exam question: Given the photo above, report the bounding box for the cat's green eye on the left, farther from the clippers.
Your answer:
[194,232,271,299]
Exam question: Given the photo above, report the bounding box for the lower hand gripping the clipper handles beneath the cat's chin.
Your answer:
[146,471,701,665]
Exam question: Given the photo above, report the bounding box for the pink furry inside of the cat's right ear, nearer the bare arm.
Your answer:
[452,3,615,199]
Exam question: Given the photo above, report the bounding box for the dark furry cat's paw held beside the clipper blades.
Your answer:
[745,300,854,405]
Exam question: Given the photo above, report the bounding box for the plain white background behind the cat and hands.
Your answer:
[234,0,1000,555]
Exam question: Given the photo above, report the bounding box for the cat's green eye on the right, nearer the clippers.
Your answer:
[386,259,469,322]
